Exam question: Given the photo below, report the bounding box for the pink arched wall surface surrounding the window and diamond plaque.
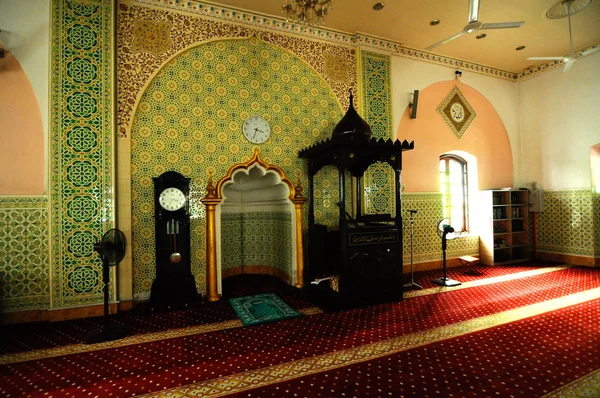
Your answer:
[396,79,513,192]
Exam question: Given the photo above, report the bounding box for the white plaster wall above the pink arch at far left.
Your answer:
[0,0,51,192]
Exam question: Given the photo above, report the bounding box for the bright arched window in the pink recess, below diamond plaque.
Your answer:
[440,154,469,232]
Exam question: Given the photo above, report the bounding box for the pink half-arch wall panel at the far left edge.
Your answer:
[0,43,44,195]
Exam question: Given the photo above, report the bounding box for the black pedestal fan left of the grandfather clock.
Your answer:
[83,228,127,344]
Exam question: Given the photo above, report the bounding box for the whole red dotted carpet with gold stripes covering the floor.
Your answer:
[0,264,600,397]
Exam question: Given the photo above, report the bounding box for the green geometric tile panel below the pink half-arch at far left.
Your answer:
[0,197,50,312]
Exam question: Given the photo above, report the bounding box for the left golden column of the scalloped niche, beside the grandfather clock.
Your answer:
[200,172,221,301]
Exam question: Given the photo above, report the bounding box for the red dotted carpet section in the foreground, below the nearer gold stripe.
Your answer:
[224,300,600,398]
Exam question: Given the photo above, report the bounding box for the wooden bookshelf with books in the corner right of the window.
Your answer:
[479,189,529,265]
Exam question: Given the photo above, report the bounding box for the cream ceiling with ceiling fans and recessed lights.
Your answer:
[205,0,600,72]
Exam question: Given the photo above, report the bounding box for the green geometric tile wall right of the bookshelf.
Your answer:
[536,188,600,257]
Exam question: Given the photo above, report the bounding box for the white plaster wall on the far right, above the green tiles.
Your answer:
[518,53,600,189]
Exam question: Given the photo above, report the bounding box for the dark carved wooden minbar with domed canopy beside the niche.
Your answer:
[299,95,414,311]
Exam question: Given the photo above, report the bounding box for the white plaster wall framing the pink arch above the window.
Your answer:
[390,56,525,186]
